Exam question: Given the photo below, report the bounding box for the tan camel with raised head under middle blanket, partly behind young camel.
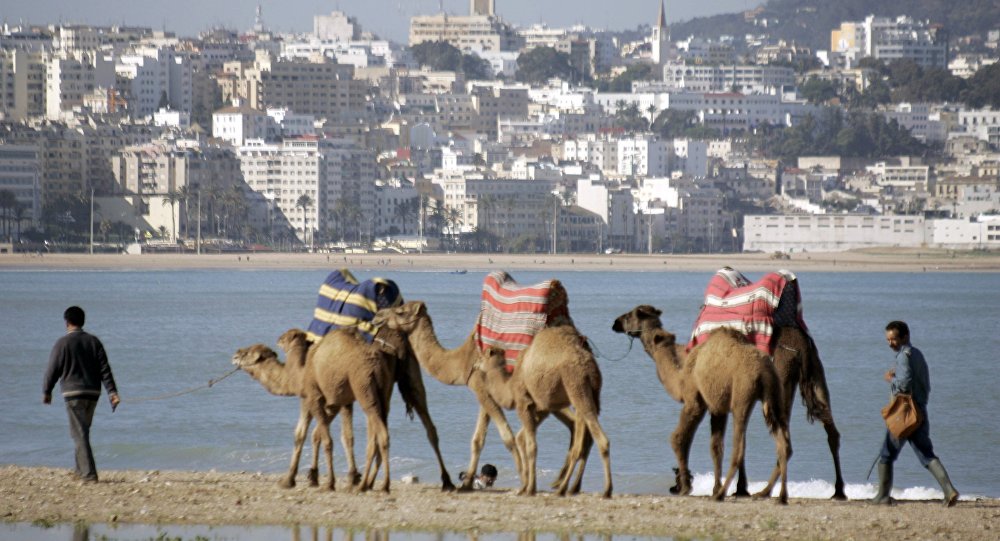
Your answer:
[372,301,592,494]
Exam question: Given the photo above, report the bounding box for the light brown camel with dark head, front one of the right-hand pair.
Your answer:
[611,305,792,504]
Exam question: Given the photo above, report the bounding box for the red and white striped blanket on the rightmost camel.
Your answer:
[687,267,808,355]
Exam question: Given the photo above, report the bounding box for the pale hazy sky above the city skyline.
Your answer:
[0,0,763,43]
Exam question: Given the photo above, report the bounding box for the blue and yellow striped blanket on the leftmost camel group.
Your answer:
[306,269,403,343]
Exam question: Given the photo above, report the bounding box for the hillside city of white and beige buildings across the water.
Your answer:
[0,0,1000,253]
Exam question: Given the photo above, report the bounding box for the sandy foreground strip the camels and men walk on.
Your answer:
[0,465,1000,540]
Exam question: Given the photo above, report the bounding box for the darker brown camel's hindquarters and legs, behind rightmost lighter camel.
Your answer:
[736,326,847,500]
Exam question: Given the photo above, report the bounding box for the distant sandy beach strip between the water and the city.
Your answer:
[0,248,1000,272]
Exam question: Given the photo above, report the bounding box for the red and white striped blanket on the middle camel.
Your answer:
[475,271,573,371]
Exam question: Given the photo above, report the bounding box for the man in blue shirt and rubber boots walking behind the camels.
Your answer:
[871,321,958,507]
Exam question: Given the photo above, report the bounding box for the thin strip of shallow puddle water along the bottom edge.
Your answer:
[0,522,672,541]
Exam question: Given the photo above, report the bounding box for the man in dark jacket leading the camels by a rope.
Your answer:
[42,306,121,483]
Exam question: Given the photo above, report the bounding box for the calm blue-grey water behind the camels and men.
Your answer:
[0,269,1000,498]
